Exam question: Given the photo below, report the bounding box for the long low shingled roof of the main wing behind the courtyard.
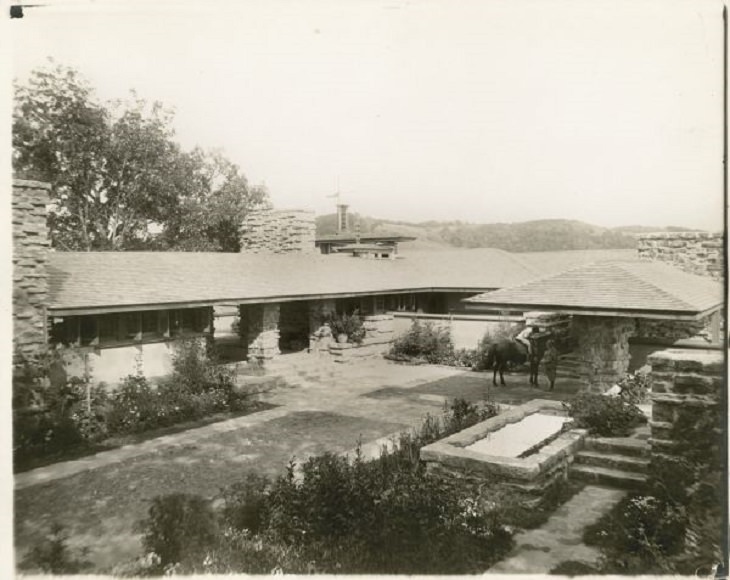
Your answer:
[49,249,538,314]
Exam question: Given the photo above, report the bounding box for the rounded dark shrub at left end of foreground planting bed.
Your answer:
[141,493,218,566]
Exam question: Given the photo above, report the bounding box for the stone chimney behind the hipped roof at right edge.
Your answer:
[638,232,724,280]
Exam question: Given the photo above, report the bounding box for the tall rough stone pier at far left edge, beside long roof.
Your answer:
[12,179,51,364]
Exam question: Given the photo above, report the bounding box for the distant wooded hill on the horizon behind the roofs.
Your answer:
[317,214,689,252]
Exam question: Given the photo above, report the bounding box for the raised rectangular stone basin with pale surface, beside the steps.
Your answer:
[421,399,586,488]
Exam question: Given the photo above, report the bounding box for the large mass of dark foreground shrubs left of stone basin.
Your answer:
[115,400,512,574]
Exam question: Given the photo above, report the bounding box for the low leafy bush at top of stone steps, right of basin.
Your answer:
[563,393,647,437]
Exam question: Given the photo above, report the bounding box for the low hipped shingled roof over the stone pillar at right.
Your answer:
[466,260,723,318]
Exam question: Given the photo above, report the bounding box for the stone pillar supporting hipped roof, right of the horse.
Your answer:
[573,315,634,392]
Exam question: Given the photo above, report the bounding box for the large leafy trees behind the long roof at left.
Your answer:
[12,61,269,252]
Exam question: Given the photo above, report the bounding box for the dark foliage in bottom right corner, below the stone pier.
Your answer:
[584,392,724,576]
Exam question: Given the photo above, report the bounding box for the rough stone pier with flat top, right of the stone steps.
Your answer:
[649,349,725,490]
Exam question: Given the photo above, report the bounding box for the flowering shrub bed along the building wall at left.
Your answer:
[13,340,251,464]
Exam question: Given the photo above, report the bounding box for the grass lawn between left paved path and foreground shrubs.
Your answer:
[15,411,405,571]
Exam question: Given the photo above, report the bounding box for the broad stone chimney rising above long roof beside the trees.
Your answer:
[241,210,316,254]
